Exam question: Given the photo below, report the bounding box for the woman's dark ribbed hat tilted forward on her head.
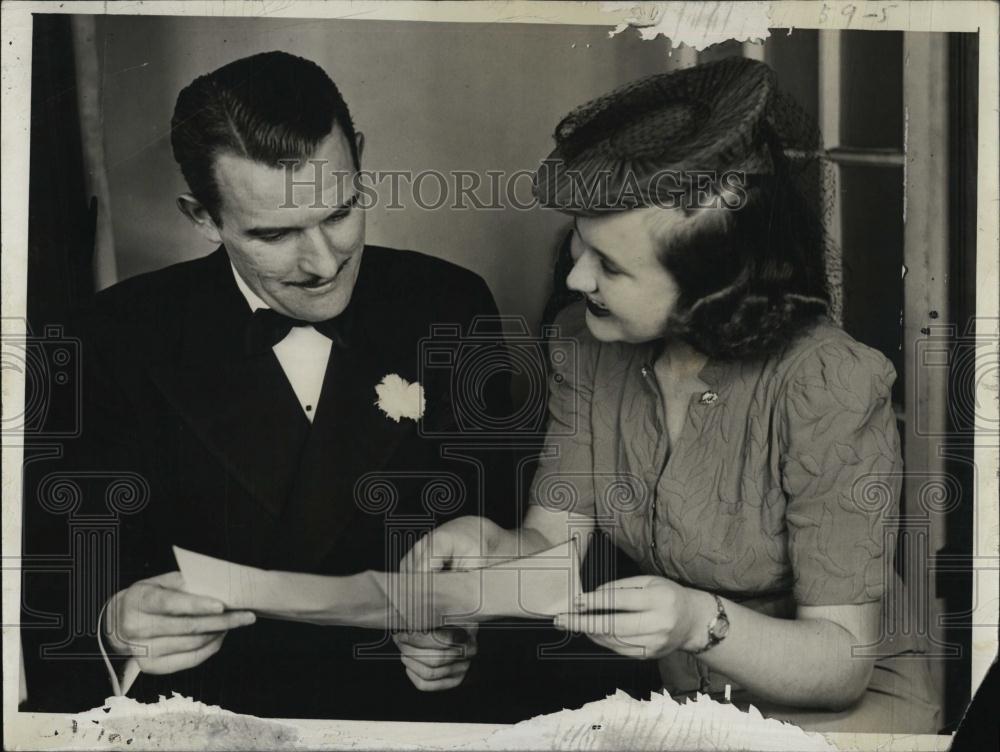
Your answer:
[535,57,778,214]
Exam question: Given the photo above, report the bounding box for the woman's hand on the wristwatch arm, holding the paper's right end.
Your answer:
[555,576,715,659]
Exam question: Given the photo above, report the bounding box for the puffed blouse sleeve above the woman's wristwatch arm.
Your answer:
[780,334,902,606]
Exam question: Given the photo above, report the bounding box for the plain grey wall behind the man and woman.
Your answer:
[98,16,688,325]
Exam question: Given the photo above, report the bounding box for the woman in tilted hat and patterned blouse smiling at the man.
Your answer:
[396,59,938,733]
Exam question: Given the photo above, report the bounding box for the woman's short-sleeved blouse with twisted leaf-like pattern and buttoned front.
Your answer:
[532,305,902,606]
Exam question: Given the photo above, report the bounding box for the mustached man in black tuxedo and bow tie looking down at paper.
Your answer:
[23,52,514,720]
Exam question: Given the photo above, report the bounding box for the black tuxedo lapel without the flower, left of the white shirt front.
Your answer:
[150,249,309,518]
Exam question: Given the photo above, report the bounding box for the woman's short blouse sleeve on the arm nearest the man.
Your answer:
[529,305,600,515]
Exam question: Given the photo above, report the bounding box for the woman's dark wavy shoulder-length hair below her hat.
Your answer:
[660,140,830,360]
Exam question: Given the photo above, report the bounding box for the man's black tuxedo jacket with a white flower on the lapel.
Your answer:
[23,246,514,720]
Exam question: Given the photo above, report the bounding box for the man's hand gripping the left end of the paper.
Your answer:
[104,572,256,674]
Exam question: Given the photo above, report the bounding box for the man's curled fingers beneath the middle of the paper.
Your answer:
[392,626,476,692]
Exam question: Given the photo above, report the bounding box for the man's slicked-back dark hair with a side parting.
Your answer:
[170,52,360,223]
